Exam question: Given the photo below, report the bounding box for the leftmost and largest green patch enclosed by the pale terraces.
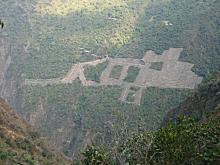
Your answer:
[84,62,108,83]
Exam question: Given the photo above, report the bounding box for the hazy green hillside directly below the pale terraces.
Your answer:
[20,81,190,155]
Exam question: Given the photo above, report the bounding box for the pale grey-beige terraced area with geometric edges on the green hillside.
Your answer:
[25,48,202,105]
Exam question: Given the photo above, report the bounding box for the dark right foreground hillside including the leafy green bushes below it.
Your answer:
[82,74,220,165]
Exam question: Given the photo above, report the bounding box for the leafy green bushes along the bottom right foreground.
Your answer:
[83,117,220,165]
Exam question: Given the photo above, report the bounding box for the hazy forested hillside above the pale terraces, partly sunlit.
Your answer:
[0,0,220,78]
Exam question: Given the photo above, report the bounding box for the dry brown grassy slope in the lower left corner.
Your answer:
[0,98,71,165]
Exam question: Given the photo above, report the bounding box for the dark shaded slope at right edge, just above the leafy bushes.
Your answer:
[163,72,220,124]
